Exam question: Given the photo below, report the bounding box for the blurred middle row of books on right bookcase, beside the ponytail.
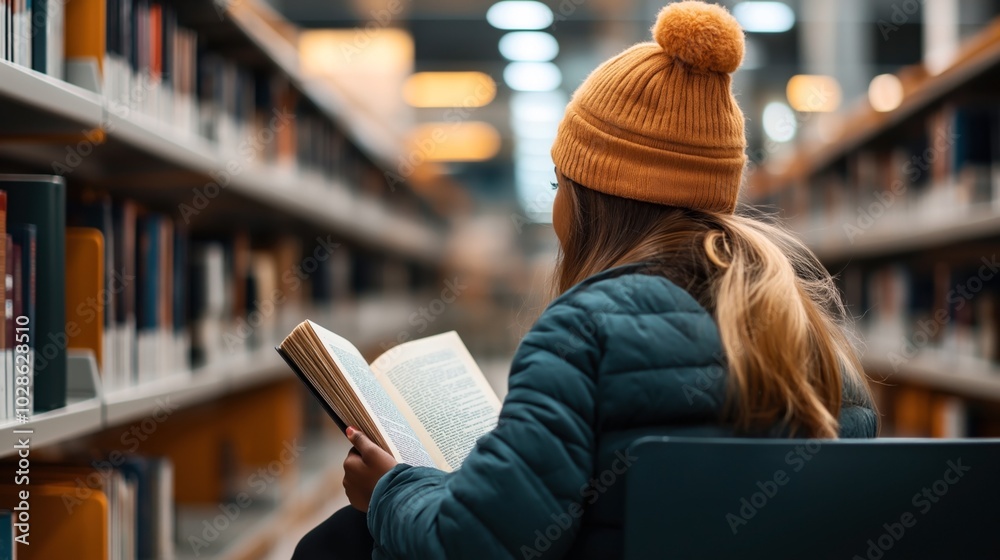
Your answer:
[843,259,1000,367]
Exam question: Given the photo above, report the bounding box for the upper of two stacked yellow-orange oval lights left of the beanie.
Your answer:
[403,72,497,107]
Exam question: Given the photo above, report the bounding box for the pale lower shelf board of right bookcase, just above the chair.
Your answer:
[862,350,1000,402]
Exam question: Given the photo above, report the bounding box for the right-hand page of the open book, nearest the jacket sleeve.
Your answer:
[372,332,500,469]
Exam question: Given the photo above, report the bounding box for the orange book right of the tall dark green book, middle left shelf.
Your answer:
[66,228,104,375]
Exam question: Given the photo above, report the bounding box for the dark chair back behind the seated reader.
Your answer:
[625,437,1000,560]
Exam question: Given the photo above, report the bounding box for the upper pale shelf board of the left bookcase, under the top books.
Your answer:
[0,23,445,263]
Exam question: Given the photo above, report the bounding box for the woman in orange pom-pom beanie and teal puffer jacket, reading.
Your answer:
[297,2,877,559]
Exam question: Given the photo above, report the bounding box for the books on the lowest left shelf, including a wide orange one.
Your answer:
[0,453,174,560]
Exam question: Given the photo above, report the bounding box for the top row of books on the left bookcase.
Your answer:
[0,0,410,202]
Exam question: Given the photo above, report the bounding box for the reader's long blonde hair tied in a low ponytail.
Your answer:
[554,178,872,438]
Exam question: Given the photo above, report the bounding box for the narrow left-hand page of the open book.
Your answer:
[309,321,436,467]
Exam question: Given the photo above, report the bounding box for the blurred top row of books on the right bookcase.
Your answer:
[761,101,1000,236]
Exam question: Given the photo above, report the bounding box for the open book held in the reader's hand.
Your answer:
[276,321,500,472]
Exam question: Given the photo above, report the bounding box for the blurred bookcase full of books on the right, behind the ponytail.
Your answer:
[749,16,1000,437]
